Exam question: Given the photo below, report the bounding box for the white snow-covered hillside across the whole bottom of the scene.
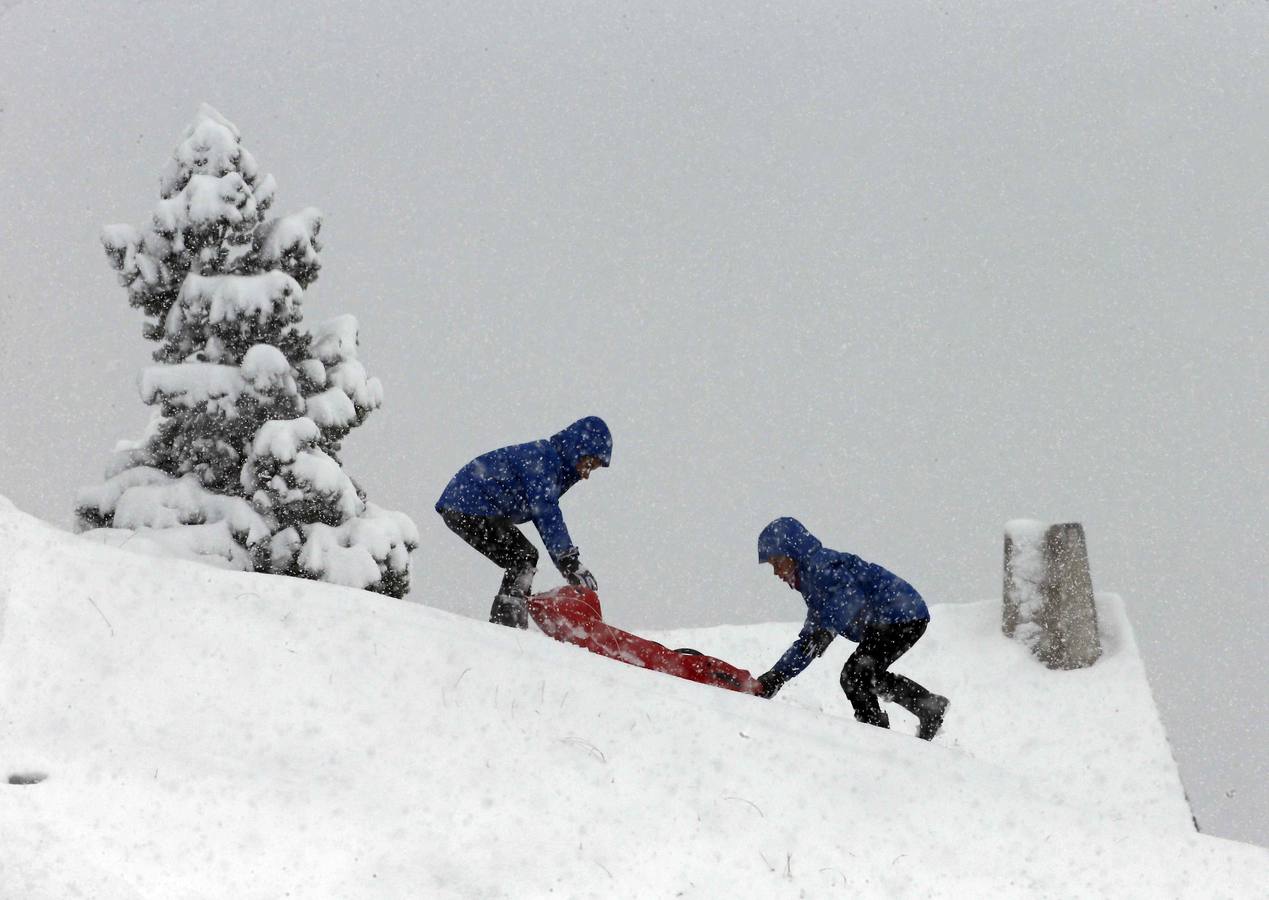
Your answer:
[0,500,1269,897]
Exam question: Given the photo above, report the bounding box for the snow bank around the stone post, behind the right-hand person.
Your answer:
[651,594,1194,830]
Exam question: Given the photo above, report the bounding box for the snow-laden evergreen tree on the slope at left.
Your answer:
[76,104,419,597]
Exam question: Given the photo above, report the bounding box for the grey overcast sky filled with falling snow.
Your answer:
[0,0,1269,844]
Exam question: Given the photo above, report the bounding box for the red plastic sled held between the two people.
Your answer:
[529,585,763,694]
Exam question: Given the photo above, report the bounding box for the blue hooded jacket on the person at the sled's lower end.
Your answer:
[758,518,930,679]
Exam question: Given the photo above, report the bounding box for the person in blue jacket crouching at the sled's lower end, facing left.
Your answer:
[758,517,948,740]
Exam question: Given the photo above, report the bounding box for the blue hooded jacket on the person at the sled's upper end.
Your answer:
[437,415,613,561]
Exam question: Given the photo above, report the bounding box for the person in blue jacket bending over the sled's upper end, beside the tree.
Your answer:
[437,415,613,628]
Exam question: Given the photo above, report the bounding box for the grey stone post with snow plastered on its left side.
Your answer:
[1003,519,1101,669]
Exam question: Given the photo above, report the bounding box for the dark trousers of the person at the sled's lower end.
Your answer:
[841,618,930,729]
